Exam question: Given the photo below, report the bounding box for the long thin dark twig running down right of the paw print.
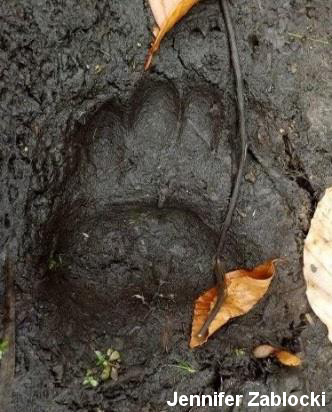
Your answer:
[198,0,248,336]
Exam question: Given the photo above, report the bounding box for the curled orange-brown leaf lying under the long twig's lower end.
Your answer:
[189,260,275,348]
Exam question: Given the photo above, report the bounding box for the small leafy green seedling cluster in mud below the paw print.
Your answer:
[83,348,121,388]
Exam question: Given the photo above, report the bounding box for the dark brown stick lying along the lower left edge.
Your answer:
[0,257,15,412]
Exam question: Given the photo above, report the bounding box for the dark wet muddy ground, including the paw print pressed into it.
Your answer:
[0,0,332,412]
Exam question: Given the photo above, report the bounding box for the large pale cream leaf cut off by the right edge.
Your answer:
[303,187,332,342]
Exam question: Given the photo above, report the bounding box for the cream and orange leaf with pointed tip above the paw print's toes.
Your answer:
[144,0,199,70]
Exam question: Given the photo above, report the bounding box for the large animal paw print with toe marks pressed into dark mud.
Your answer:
[44,83,231,314]
